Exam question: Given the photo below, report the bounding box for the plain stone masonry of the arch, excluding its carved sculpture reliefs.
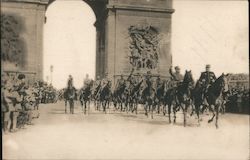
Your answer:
[1,0,174,82]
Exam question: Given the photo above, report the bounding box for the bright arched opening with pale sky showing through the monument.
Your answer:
[43,1,96,89]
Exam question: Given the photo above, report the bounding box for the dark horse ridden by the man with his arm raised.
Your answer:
[173,70,194,127]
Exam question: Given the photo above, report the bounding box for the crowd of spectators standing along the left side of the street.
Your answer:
[1,73,57,133]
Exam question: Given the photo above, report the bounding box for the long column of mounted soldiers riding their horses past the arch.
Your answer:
[64,65,228,127]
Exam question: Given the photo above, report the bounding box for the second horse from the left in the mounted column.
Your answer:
[79,80,93,114]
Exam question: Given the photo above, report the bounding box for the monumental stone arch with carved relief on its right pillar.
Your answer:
[1,0,174,80]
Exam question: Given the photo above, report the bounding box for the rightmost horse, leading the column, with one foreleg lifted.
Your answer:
[205,73,228,129]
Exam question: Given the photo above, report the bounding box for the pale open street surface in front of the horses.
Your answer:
[3,102,249,160]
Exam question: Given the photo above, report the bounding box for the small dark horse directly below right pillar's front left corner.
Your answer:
[100,81,112,113]
